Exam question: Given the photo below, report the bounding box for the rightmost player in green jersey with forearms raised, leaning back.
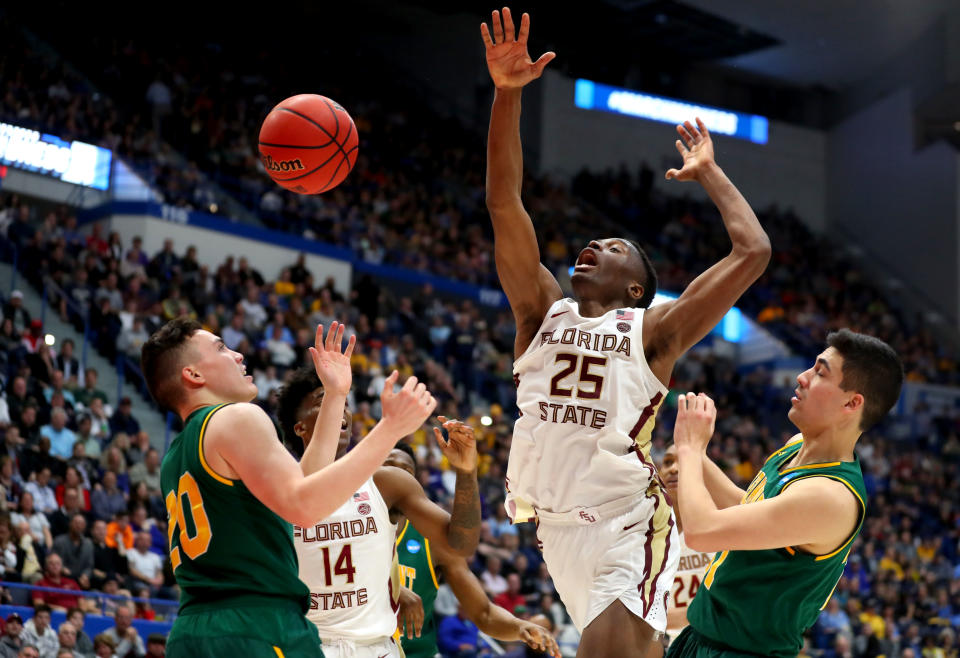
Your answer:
[667,329,903,658]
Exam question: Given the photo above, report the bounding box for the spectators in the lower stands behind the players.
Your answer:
[0,188,960,657]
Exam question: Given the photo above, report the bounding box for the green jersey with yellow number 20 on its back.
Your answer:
[160,405,309,614]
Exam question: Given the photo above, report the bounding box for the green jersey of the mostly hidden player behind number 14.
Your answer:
[397,521,440,658]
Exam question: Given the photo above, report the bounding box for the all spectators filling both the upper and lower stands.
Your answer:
[0,14,960,658]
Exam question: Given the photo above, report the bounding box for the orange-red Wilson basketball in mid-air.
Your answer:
[259,94,359,194]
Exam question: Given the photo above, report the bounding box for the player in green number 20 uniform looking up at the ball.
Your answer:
[141,318,436,658]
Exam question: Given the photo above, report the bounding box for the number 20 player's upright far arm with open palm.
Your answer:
[300,321,356,475]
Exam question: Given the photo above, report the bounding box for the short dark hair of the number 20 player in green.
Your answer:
[140,317,203,411]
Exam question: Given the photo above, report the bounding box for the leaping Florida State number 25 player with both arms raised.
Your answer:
[481,9,770,658]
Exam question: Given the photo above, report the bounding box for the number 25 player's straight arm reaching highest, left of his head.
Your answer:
[480,8,562,355]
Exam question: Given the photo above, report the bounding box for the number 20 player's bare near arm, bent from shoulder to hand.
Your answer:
[210,375,437,525]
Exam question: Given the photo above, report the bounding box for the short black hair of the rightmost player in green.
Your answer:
[827,329,903,432]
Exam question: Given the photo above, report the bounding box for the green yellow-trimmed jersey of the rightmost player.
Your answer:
[687,441,867,657]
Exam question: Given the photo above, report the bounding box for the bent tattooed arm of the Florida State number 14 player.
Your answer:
[374,416,481,557]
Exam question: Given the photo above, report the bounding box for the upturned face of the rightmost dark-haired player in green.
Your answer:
[787,347,858,434]
